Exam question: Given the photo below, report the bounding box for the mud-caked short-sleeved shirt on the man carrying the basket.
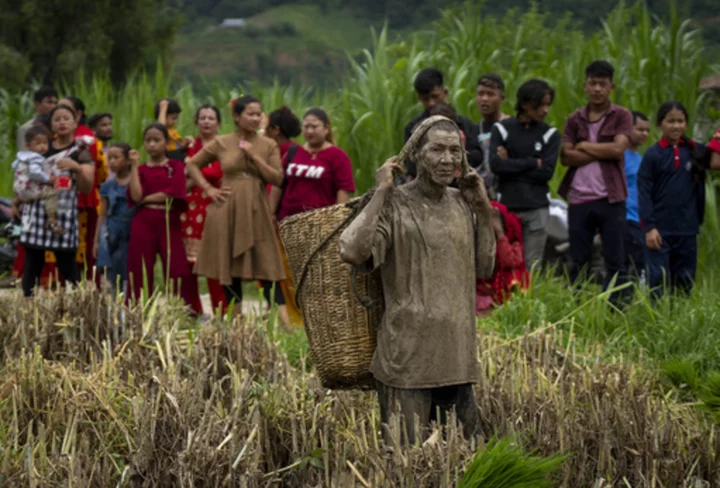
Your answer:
[365,183,495,388]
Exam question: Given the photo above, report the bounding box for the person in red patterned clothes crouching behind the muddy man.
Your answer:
[475,202,530,315]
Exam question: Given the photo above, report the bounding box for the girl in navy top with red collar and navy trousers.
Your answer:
[638,101,710,297]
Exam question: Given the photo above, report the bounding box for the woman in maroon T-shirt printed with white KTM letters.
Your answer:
[270,108,355,221]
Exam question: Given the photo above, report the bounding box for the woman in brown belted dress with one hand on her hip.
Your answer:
[187,95,285,312]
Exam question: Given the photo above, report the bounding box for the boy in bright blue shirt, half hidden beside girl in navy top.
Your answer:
[625,112,650,280]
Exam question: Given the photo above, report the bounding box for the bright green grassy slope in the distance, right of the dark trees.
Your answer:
[174,5,402,85]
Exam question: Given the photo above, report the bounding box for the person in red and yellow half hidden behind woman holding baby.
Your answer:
[58,97,108,284]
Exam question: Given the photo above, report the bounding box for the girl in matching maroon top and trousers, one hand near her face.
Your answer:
[127,123,192,305]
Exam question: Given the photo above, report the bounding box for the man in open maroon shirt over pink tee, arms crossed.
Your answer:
[558,61,633,302]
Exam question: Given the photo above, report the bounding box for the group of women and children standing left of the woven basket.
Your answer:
[13,87,355,325]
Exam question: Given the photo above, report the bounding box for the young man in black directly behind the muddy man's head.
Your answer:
[405,68,483,180]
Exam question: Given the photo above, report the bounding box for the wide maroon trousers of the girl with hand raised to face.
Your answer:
[127,208,192,306]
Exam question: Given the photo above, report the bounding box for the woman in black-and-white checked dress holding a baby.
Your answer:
[20,105,95,297]
